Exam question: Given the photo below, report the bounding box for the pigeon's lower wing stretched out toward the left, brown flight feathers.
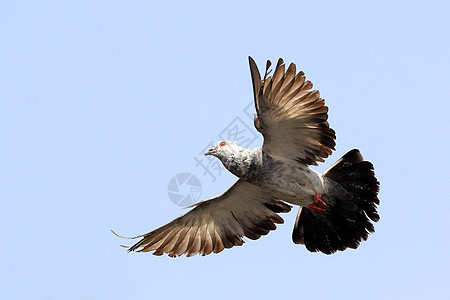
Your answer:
[115,180,291,257]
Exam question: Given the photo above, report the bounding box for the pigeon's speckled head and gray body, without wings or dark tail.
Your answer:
[208,141,351,206]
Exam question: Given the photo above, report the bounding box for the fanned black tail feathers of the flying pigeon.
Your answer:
[292,149,380,254]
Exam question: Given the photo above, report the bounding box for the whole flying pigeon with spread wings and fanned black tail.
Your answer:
[113,56,380,257]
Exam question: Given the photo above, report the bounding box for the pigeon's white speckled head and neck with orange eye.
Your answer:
[205,141,254,178]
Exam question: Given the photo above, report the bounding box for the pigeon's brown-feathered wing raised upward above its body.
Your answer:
[249,57,336,165]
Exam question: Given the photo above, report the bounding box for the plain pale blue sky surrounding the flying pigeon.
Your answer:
[0,1,450,299]
